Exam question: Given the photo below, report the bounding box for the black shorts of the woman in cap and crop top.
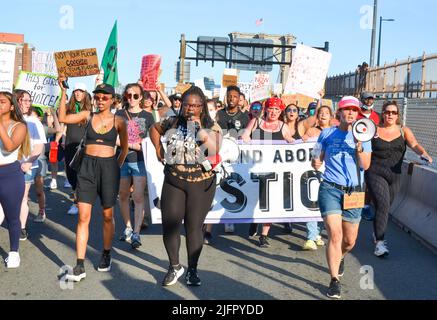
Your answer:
[76,154,120,208]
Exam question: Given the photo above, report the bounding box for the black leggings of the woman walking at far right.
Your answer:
[366,166,401,241]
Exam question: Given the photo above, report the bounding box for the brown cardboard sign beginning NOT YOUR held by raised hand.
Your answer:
[54,48,100,77]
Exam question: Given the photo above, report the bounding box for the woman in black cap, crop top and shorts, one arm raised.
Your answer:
[58,77,128,281]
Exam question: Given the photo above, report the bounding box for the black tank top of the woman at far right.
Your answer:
[369,128,407,173]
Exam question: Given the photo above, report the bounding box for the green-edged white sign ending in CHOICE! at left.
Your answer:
[16,71,61,108]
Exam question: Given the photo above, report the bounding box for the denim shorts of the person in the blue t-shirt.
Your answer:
[319,182,363,224]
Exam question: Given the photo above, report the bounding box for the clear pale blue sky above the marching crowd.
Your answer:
[0,0,437,92]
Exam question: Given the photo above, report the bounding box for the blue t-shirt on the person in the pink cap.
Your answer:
[317,127,372,187]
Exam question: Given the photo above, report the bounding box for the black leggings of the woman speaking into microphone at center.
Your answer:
[161,174,216,268]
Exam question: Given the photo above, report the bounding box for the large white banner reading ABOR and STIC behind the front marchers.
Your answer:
[143,138,322,223]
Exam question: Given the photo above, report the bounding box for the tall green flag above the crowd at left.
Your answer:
[100,20,119,88]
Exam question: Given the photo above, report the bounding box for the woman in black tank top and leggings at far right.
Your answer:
[365,101,432,257]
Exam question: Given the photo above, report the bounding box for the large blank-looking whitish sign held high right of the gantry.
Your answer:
[284,44,332,99]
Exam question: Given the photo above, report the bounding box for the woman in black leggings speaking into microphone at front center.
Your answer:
[150,87,221,286]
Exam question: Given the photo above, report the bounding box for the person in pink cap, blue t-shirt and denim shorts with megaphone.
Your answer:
[312,96,372,299]
